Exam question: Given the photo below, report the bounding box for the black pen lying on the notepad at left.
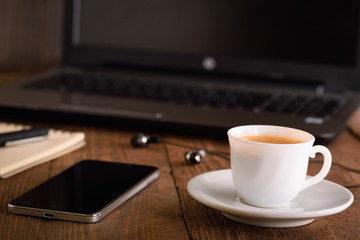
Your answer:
[0,127,50,147]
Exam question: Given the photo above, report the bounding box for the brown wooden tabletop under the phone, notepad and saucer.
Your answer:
[0,109,360,239]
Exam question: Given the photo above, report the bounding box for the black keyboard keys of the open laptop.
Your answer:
[25,73,341,119]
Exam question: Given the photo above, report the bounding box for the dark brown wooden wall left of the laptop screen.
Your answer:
[0,0,64,70]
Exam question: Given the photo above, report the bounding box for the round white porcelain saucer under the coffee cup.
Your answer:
[187,169,354,227]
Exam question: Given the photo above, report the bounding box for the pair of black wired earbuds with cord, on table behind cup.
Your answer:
[131,133,230,164]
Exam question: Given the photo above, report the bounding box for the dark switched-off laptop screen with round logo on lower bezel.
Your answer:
[65,0,360,88]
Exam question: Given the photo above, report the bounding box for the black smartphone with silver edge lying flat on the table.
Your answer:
[8,160,159,223]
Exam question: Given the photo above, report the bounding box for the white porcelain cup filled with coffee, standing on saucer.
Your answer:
[228,125,332,208]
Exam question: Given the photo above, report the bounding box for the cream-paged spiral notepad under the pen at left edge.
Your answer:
[0,122,85,178]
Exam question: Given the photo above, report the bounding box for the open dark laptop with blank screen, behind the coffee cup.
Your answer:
[0,0,360,141]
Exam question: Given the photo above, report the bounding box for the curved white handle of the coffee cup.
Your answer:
[301,145,332,190]
